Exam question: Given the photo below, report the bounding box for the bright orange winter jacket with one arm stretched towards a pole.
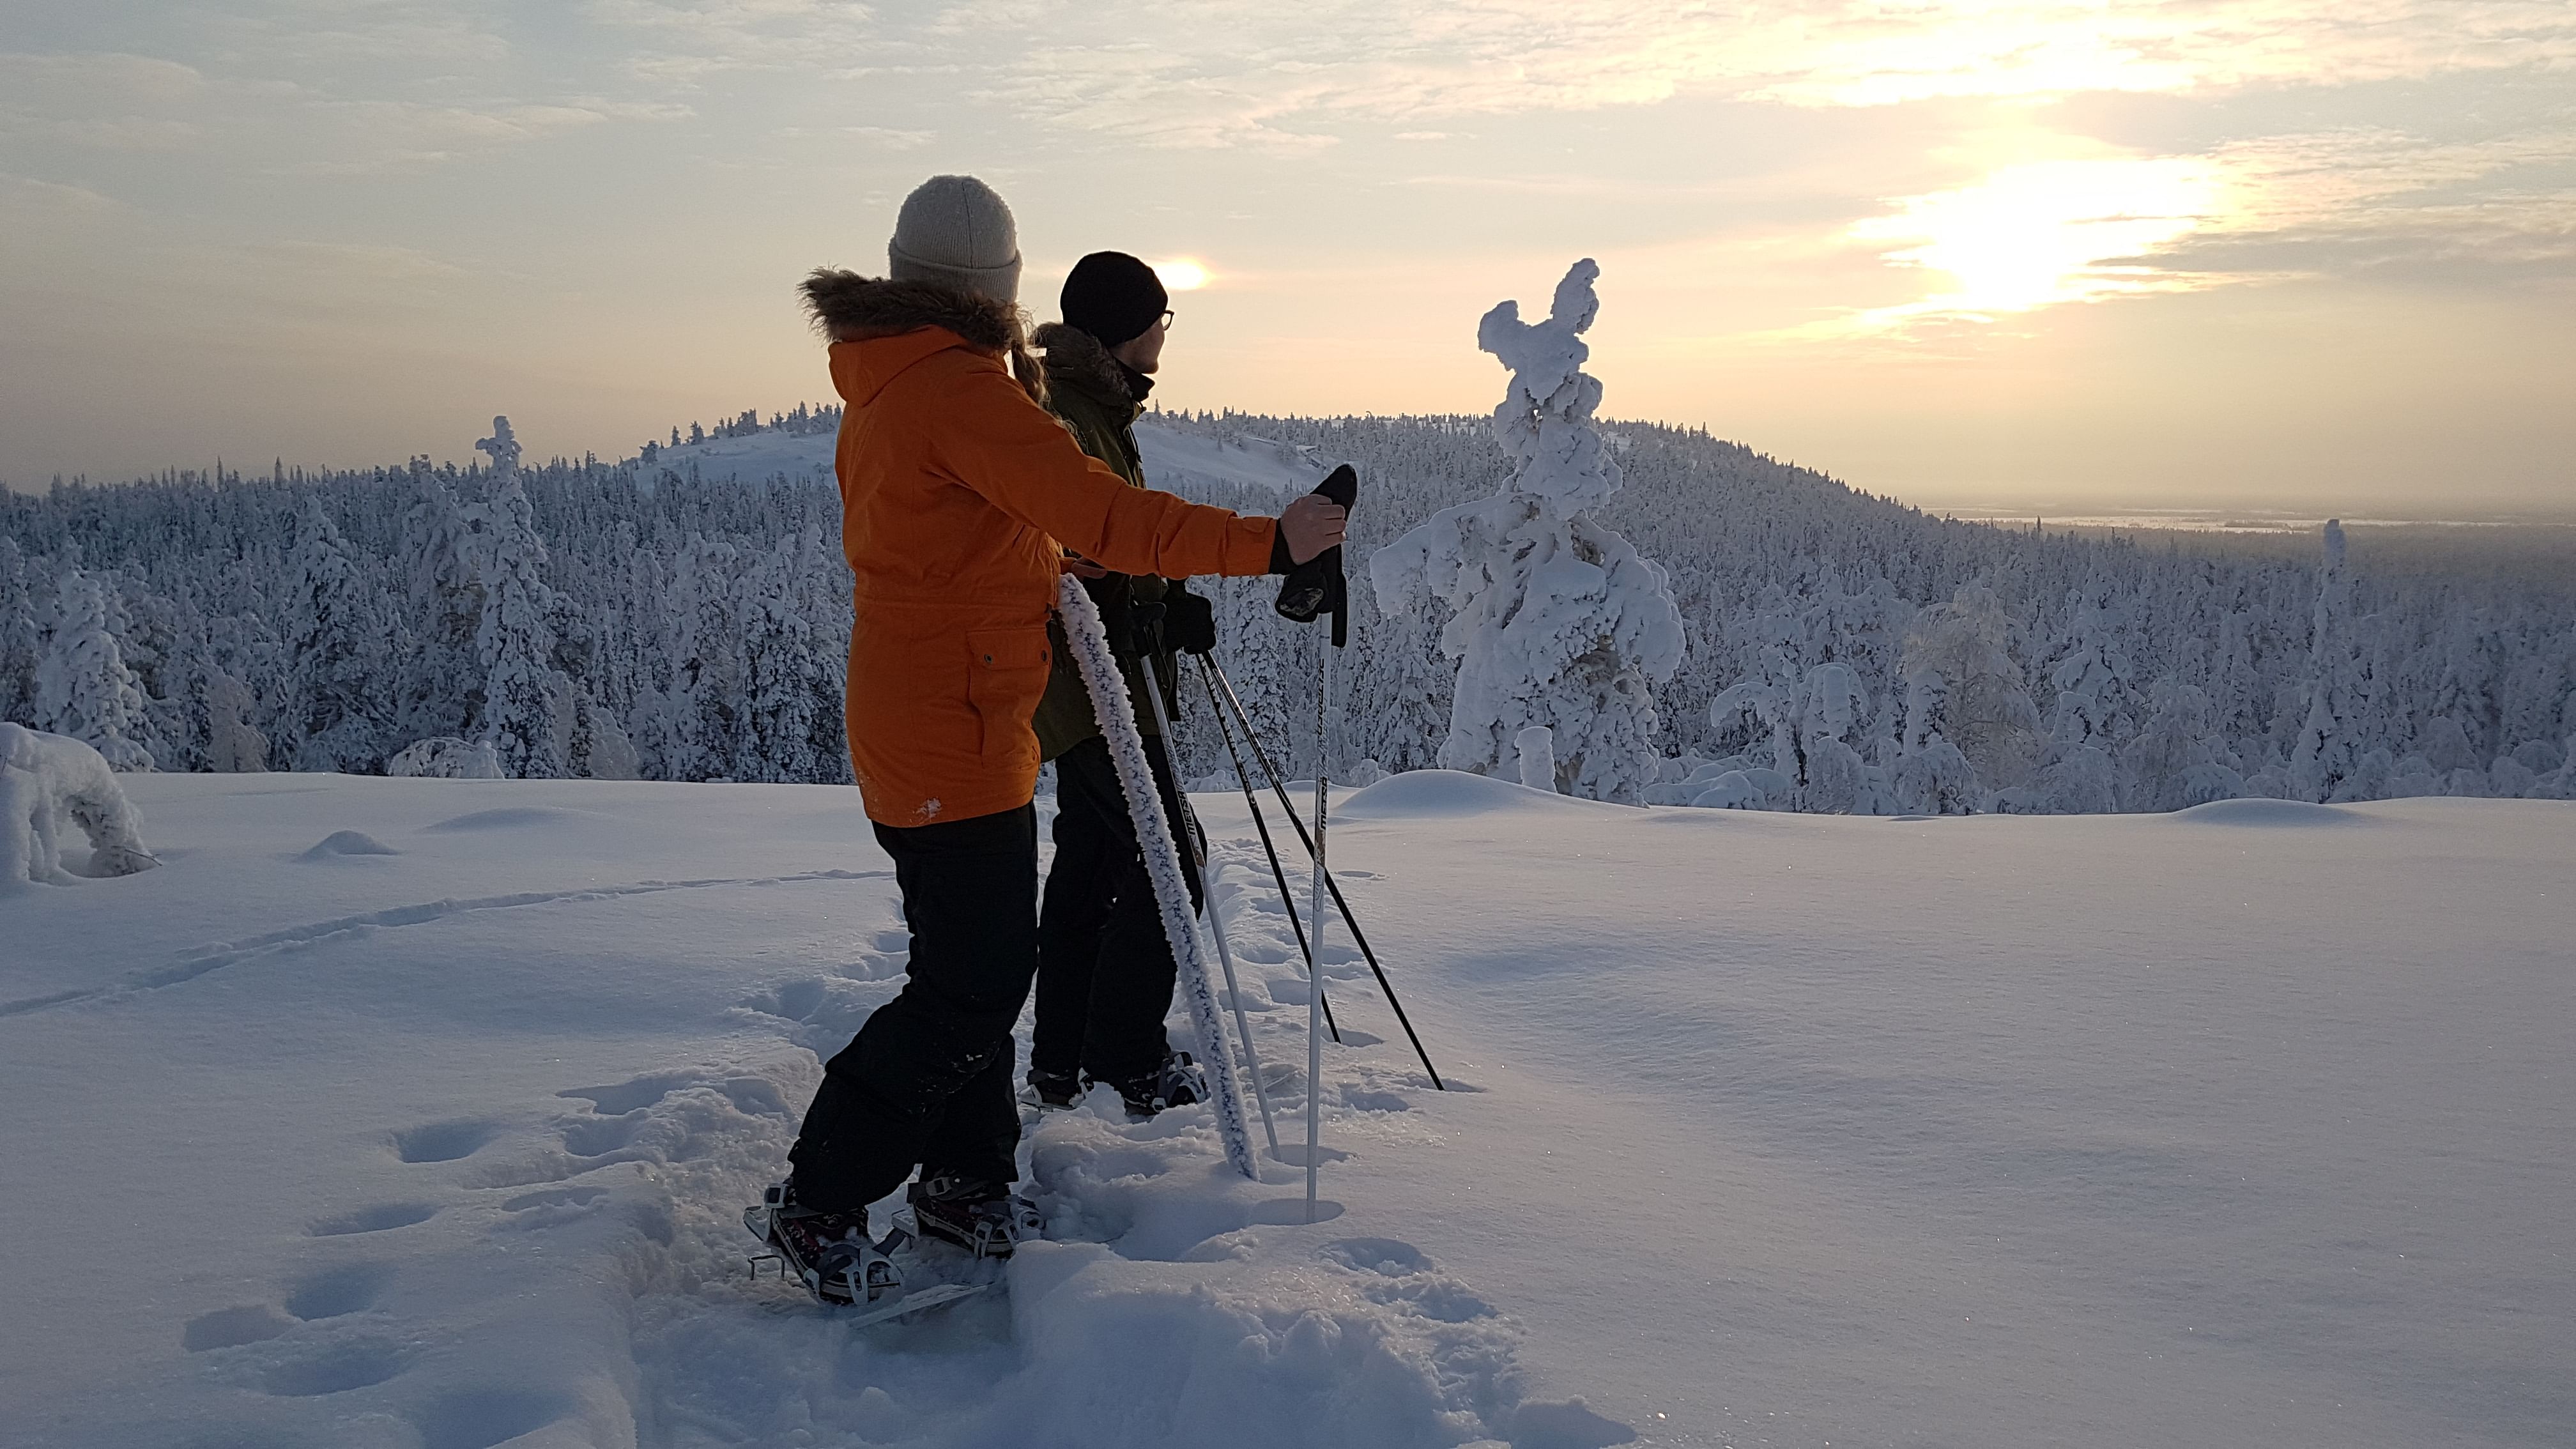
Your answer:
[832,325,1278,825]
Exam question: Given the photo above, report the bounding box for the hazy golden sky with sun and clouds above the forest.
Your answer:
[0,0,2576,516]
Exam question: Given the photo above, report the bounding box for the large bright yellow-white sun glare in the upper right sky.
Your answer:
[1850,157,2221,314]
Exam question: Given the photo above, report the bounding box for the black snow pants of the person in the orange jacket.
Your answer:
[788,804,1038,1212]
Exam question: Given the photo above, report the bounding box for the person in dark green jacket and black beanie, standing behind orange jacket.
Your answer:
[1028,252,1216,1116]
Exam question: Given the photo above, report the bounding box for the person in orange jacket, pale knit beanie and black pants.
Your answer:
[768,175,1342,1302]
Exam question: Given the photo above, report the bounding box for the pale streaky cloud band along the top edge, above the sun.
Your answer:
[880,0,2576,147]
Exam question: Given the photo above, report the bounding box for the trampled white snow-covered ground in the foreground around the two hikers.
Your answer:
[0,774,2576,1449]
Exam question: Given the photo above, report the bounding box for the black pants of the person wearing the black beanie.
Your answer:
[1028,735,1200,1083]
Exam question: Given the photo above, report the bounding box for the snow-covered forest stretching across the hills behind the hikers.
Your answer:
[0,408,2576,815]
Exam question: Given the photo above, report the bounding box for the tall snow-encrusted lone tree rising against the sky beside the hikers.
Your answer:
[1368,258,1682,804]
